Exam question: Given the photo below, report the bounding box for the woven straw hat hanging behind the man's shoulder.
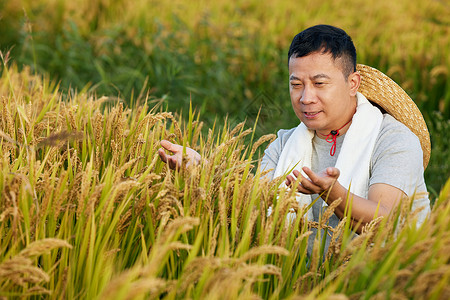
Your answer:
[356,64,431,169]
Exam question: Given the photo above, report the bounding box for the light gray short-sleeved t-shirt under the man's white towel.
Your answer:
[261,114,430,253]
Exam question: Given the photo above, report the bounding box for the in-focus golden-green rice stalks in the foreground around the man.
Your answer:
[0,64,450,299]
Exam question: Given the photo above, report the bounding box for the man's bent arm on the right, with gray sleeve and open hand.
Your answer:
[287,115,429,232]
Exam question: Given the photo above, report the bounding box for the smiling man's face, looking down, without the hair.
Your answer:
[289,52,360,135]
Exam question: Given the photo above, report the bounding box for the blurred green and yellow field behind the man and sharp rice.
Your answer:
[0,0,450,198]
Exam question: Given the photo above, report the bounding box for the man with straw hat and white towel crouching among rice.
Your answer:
[159,25,430,248]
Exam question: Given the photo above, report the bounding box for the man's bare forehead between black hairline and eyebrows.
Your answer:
[289,52,342,77]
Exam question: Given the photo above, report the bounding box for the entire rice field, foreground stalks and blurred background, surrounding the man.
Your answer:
[0,0,450,299]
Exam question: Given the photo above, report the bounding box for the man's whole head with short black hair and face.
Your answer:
[289,25,361,136]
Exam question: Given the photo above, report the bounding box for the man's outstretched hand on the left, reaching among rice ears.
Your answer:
[158,140,202,169]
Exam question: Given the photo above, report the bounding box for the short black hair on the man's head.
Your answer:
[288,25,356,80]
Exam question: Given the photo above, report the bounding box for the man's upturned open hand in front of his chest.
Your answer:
[286,167,340,194]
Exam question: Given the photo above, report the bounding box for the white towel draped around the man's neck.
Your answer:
[274,92,383,221]
